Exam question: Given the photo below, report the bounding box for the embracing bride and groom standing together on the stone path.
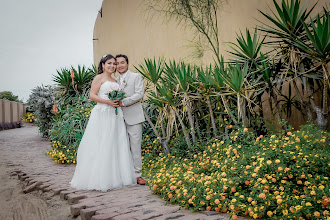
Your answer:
[70,54,146,191]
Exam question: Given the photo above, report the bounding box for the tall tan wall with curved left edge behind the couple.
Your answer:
[94,0,327,67]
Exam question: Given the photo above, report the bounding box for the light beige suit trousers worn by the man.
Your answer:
[125,123,142,177]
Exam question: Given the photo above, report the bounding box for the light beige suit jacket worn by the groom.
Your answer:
[117,70,145,125]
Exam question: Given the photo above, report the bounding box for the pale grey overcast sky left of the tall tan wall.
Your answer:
[0,0,102,101]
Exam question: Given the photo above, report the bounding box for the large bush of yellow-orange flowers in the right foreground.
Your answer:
[143,125,330,219]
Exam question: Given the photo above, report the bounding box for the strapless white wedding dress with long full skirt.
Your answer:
[70,81,136,191]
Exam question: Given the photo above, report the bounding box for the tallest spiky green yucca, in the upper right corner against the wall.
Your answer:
[259,0,329,129]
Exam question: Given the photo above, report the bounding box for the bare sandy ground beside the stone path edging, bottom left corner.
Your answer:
[0,162,80,220]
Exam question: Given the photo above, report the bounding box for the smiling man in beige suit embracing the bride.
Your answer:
[116,54,146,185]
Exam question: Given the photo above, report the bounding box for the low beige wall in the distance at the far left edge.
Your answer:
[0,99,26,123]
